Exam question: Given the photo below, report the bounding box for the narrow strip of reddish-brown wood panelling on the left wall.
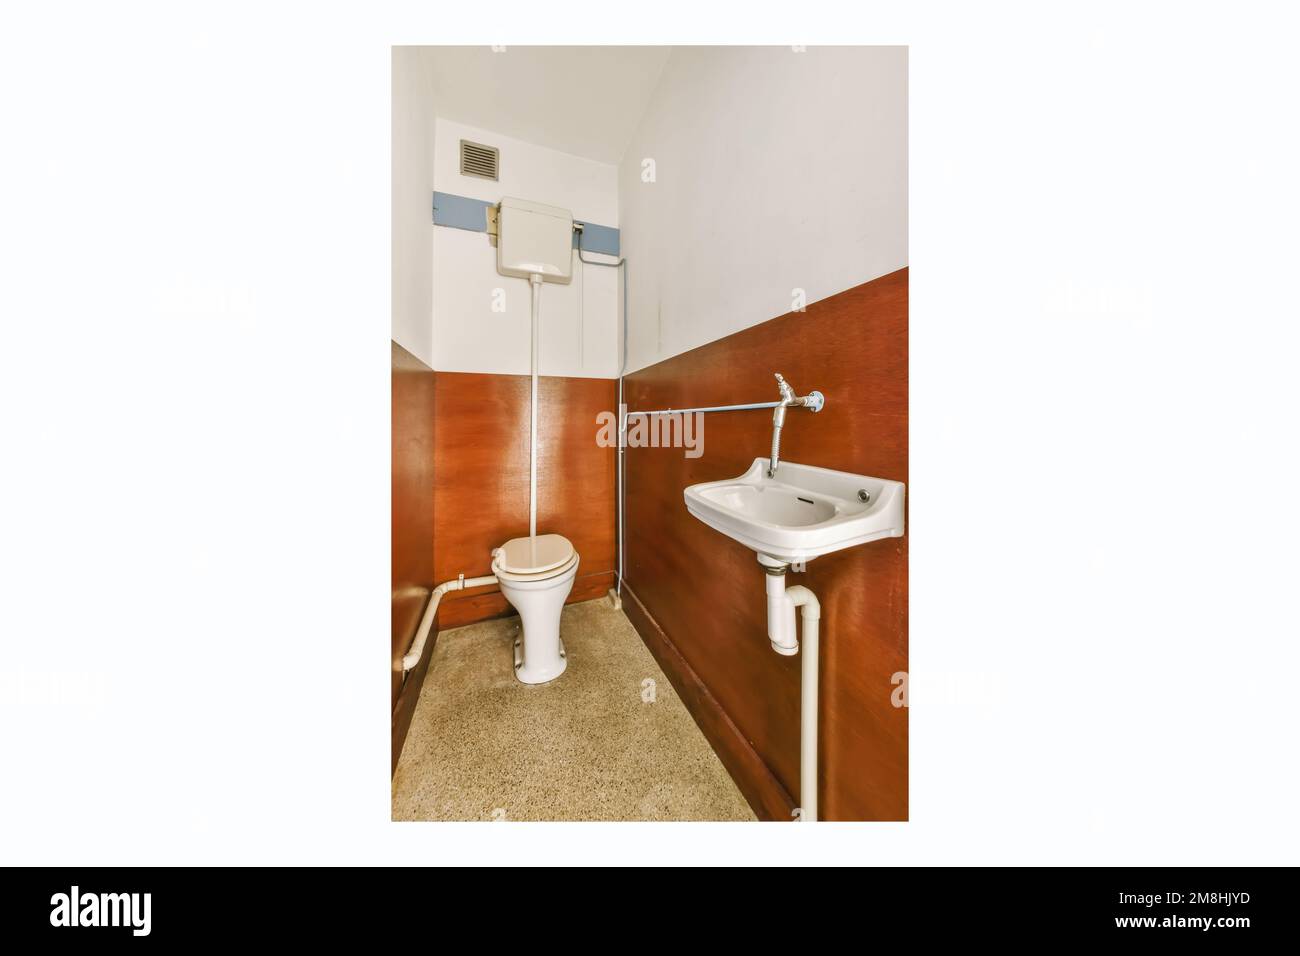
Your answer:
[391,342,436,770]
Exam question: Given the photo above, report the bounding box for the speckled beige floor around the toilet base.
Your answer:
[393,600,754,821]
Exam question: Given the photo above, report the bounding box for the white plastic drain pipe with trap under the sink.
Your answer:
[758,554,822,823]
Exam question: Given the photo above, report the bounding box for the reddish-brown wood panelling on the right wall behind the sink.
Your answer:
[621,269,910,821]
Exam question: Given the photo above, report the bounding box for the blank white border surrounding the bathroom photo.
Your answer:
[0,3,1300,865]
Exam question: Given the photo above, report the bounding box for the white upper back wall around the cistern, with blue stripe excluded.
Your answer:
[433,118,619,378]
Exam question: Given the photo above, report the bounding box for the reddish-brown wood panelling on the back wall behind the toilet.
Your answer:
[433,372,618,627]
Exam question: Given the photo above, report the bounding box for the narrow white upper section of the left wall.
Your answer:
[391,47,434,365]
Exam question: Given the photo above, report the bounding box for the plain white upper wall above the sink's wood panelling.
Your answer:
[619,47,907,372]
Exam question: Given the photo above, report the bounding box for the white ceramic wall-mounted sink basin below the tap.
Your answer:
[683,458,904,562]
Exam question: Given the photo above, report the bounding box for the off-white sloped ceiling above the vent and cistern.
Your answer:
[423,47,672,163]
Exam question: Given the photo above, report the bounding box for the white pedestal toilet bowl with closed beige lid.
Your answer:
[491,535,577,684]
